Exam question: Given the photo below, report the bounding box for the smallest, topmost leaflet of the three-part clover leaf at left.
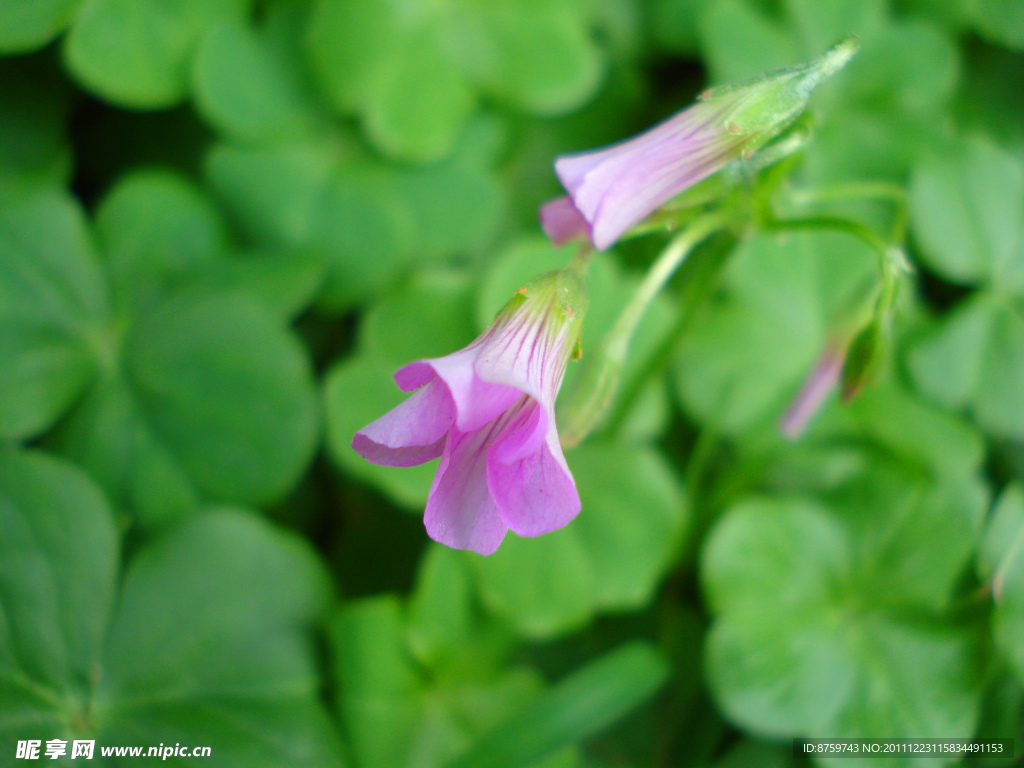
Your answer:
[96,171,227,312]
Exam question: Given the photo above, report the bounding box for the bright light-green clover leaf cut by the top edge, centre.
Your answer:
[308,0,602,162]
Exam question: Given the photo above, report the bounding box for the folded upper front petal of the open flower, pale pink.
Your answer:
[394,342,522,432]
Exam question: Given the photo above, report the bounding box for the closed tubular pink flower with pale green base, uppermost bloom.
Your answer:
[541,38,857,250]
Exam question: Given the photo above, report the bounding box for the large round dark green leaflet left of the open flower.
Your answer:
[125,294,318,504]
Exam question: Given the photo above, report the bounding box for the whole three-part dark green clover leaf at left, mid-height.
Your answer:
[0,180,318,523]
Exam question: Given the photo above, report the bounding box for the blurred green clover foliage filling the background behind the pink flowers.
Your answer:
[0,0,1024,768]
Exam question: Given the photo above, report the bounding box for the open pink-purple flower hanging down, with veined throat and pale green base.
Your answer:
[352,271,587,555]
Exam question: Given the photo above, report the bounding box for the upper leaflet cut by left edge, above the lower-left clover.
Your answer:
[0,191,110,439]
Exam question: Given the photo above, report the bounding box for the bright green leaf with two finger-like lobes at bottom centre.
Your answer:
[331,595,666,768]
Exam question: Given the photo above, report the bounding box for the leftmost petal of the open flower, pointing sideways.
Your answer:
[352,379,455,467]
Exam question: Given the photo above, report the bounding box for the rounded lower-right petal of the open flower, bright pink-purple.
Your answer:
[487,427,581,536]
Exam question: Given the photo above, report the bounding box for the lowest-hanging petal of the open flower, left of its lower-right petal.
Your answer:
[423,420,508,555]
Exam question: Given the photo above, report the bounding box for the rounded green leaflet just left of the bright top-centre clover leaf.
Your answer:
[194,20,322,142]
